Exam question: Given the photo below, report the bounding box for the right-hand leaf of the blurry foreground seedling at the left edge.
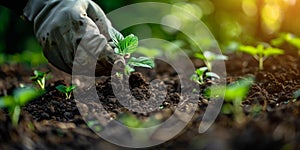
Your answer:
[14,87,40,106]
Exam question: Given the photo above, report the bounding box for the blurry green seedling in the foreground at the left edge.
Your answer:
[0,87,41,126]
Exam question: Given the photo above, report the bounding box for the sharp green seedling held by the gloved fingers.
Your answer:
[110,30,154,75]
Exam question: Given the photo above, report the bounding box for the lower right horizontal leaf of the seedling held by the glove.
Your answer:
[127,57,154,69]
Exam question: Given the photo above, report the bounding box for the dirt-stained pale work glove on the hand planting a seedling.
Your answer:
[24,0,125,75]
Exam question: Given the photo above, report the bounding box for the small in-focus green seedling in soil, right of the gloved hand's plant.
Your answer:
[191,67,220,85]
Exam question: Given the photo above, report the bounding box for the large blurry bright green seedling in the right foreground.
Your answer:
[205,77,254,123]
